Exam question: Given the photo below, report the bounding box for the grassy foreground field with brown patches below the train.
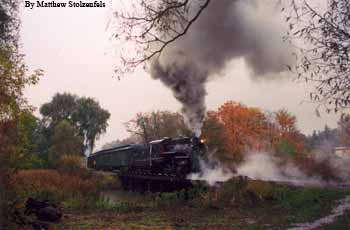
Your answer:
[53,181,350,230]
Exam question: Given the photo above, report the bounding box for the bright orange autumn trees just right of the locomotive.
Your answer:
[203,101,304,164]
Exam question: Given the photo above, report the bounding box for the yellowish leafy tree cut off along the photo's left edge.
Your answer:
[0,0,41,226]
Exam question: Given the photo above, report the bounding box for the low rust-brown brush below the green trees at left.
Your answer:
[11,170,97,199]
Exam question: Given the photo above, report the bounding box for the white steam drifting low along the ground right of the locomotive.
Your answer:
[191,152,350,187]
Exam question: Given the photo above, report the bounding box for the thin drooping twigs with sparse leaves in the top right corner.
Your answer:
[287,0,350,112]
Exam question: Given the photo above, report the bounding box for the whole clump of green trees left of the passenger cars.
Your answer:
[13,93,110,169]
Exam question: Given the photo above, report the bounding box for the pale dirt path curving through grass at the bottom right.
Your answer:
[288,196,350,230]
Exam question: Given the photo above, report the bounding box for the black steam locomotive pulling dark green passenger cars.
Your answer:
[87,137,207,191]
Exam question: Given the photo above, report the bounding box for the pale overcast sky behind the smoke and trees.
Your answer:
[21,1,339,148]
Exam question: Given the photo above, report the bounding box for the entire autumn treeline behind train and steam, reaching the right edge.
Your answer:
[103,101,350,180]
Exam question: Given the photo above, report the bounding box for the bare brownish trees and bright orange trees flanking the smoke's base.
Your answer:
[103,101,305,162]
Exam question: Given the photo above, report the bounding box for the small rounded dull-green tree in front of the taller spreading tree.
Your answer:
[49,120,83,167]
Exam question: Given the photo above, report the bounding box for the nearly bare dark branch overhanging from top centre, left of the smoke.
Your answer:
[116,0,211,74]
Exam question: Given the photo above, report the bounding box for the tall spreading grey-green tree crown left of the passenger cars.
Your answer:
[40,93,110,151]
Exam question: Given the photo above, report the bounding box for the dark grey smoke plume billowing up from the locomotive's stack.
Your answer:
[150,0,290,135]
